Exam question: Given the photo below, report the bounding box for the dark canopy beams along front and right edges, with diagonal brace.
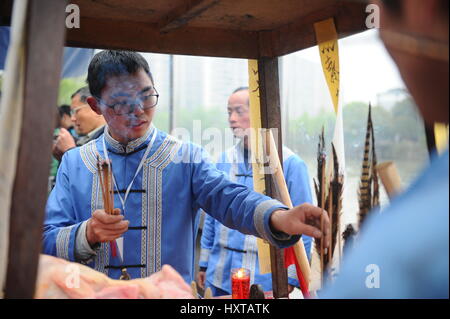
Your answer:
[66,0,366,59]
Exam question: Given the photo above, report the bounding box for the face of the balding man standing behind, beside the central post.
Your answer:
[228,90,250,138]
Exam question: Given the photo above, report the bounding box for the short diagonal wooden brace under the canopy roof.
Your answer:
[158,0,220,33]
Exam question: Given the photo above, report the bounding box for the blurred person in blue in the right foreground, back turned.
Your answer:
[320,0,449,299]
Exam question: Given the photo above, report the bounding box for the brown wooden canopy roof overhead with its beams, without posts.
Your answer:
[0,0,366,59]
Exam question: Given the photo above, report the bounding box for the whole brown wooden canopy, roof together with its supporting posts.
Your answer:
[0,0,366,298]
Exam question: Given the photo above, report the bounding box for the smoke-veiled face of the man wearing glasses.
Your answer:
[99,70,156,143]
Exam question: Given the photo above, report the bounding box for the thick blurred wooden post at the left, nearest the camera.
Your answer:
[5,0,67,298]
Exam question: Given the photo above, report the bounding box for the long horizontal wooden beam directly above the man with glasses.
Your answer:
[66,17,259,59]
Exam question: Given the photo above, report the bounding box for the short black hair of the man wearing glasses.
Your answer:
[87,50,153,98]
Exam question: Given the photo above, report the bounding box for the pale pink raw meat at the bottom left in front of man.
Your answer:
[35,255,193,299]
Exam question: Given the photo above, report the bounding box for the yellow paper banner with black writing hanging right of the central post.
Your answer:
[314,18,339,114]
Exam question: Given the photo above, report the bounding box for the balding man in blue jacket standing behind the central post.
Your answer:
[198,87,312,296]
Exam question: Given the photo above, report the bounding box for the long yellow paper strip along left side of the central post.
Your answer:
[248,60,272,274]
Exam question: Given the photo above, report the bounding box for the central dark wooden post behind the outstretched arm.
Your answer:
[258,58,289,298]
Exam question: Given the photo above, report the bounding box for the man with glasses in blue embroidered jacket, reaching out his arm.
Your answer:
[43,51,329,282]
